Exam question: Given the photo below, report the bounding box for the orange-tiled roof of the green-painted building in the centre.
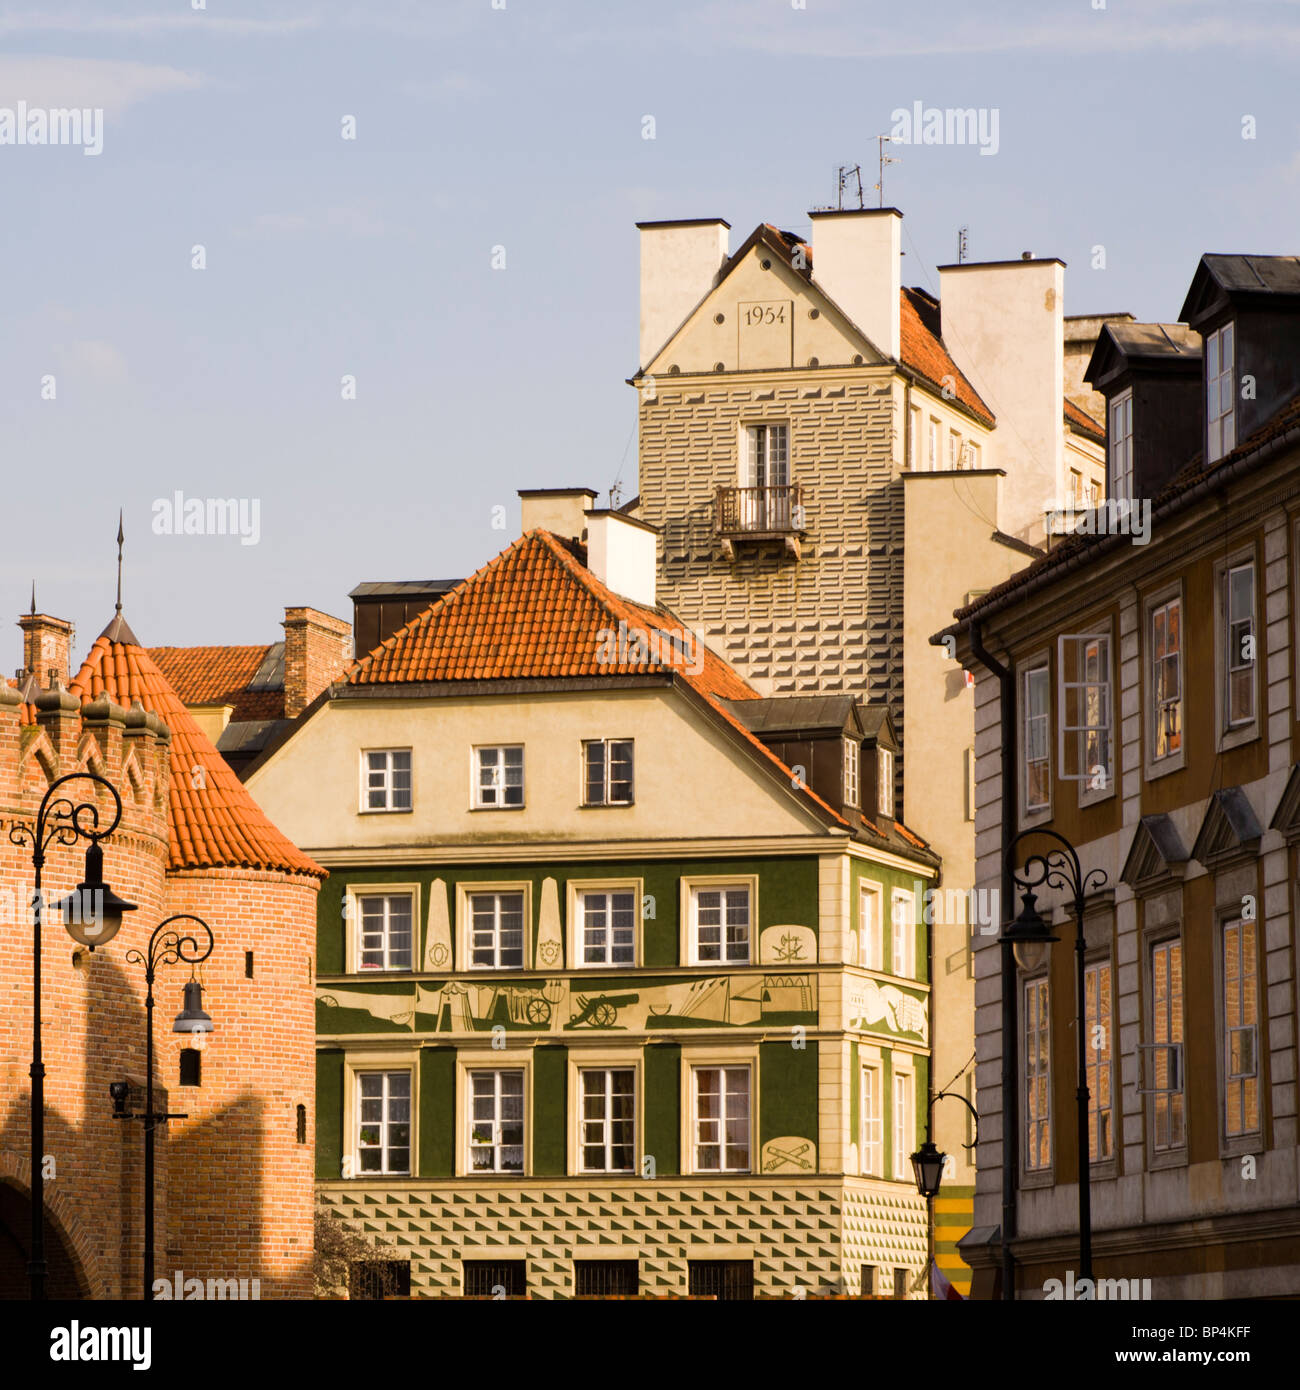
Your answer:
[348,530,873,845]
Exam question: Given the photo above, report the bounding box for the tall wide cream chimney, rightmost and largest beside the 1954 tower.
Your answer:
[939,257,1066,542]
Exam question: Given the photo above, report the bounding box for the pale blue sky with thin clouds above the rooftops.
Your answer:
[0,0,1300,671]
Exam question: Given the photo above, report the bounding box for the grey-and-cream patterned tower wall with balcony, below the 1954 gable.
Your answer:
[637,367,904,716]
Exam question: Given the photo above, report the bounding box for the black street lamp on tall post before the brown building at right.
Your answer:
[1000,826,1107,1279]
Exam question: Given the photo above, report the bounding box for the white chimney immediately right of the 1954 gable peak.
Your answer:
[808,207,902,360]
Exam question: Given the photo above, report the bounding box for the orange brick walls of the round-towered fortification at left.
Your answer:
[0,678,317,1298]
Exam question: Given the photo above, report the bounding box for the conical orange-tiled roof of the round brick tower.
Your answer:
[68,634,325,877]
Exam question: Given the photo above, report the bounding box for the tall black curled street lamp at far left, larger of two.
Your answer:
[10,773,136,1300]
